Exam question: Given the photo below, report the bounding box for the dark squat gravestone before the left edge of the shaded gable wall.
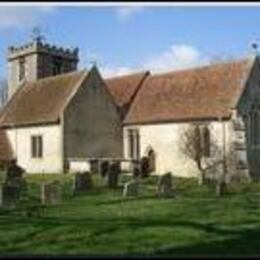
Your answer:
[73,172,93,193]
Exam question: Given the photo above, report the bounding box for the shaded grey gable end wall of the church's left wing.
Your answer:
[64,69,122,158]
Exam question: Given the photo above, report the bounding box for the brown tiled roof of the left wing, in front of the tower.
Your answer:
[0,71,87,126]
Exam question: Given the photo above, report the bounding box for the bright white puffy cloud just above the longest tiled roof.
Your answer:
[142,44,208,73]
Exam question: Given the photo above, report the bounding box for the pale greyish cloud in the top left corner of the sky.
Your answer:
[0,6,55,29]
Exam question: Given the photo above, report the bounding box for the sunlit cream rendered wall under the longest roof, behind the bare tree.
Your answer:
[123,121,232,177]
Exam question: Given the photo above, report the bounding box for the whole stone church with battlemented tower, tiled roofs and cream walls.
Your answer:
[0,39,260,181]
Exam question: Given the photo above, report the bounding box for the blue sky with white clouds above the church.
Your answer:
[0,4,260,78]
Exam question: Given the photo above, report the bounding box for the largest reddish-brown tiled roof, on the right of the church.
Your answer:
[124,58,253,124]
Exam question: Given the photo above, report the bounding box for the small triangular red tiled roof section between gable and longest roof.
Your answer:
[105,71,149,108]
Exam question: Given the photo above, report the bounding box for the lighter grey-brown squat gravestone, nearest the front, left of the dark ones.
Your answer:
[41,181,61,205]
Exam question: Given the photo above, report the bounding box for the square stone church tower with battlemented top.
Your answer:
[7,36,79,99]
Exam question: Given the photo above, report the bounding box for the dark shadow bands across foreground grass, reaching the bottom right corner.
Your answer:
[2,218,260,256]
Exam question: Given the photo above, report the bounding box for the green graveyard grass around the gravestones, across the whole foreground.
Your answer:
[0,174,260,256]
